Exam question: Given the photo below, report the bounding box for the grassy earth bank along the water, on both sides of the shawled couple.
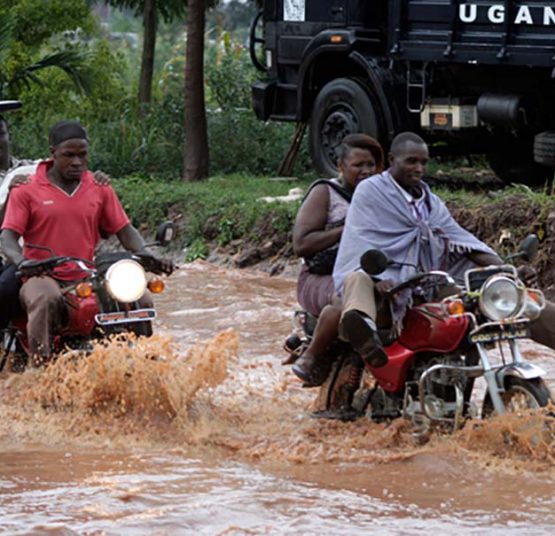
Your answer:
[111,174,555,298]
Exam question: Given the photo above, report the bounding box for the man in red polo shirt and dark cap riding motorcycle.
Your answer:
[0,121,172,363]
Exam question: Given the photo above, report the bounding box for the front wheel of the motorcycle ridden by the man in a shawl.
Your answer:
[482,376,551,418]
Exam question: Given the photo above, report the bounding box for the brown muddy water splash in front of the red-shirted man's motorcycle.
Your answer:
[0,330,238,444]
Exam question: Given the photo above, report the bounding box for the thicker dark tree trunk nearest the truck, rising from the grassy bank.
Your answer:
[183,0,209,181]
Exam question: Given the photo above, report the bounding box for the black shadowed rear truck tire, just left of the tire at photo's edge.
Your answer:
[487,140,553,186]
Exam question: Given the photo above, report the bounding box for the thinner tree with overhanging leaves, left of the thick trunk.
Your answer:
[104,0,186,104]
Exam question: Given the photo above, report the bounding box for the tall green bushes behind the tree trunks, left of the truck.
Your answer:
[9,29,311,180]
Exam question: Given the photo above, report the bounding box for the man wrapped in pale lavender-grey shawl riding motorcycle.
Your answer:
[333,132,555,367]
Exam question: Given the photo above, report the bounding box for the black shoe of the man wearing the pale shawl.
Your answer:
[341,310,388,368]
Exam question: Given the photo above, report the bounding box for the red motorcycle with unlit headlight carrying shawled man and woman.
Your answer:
[285,235,551,431]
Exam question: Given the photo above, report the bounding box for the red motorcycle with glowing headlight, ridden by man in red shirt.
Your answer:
[0,222,174,372]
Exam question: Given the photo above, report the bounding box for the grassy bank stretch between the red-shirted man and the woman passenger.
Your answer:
[115,174,310,260]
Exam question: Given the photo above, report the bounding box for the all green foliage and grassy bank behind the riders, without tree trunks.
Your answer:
[4,0,555,282]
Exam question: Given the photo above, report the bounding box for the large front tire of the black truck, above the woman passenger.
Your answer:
[309,78,379,177]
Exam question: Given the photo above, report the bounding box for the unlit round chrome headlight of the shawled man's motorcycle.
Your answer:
[480,275,525,321]
